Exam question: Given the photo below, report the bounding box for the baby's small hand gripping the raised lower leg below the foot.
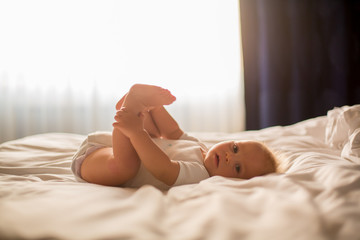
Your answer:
[113,108,144,138]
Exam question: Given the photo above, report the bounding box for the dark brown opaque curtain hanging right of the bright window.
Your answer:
[240,0,360,130]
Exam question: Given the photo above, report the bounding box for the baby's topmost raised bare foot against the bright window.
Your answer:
[123,84,176,112]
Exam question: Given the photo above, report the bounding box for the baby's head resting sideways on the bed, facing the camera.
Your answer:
[204,141,277,179]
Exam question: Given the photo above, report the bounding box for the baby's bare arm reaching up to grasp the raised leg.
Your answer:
[113,108,180,186]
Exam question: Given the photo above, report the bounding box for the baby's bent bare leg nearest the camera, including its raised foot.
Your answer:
[81,84,175,186]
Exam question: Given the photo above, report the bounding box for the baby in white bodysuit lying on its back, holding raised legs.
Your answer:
[72,84,277,189]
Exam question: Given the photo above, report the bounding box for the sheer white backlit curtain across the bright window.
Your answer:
[0,0,244,142]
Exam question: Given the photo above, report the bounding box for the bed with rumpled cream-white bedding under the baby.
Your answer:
[0,105,360,240]
